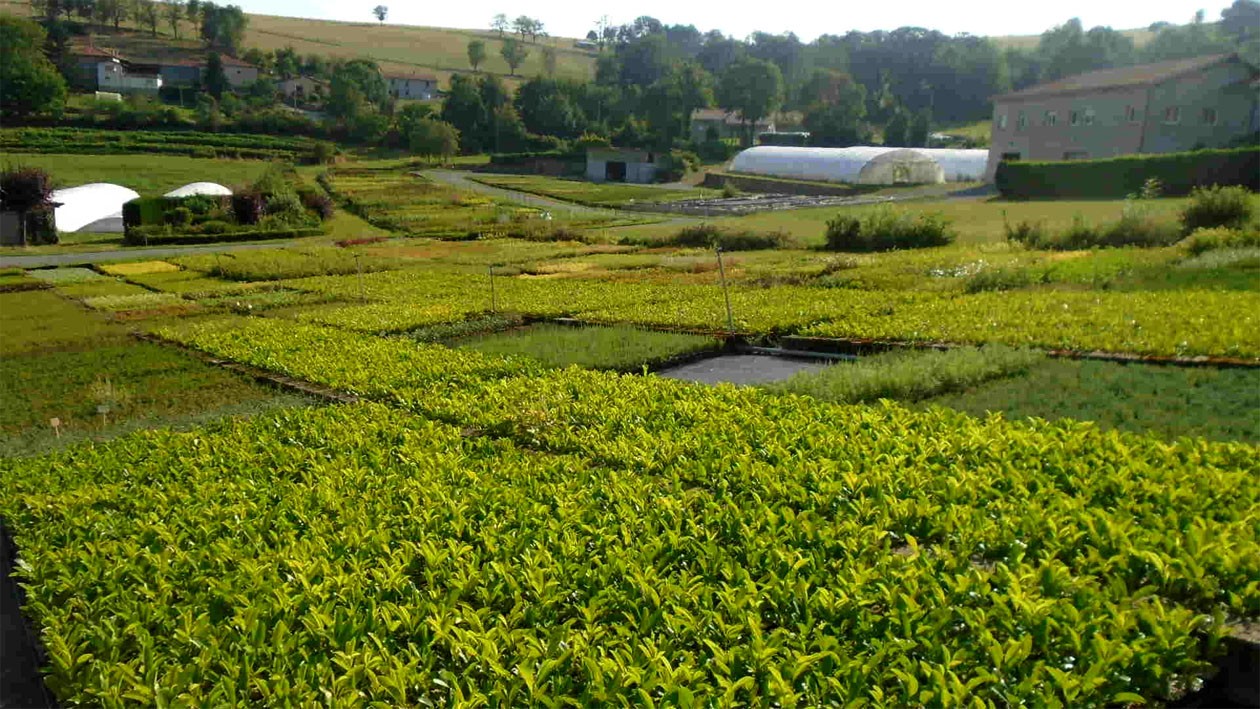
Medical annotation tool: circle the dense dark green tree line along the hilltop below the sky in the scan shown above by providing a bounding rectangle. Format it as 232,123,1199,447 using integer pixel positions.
449,0,1260,149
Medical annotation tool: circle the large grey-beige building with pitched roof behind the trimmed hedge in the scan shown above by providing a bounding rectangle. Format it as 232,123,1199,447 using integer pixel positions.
987,54,1260,180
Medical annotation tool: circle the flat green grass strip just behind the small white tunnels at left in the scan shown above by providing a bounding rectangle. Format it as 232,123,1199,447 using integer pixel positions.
0,152,270,196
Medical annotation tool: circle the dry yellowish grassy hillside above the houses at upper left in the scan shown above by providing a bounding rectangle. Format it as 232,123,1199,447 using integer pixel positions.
0,0,595,87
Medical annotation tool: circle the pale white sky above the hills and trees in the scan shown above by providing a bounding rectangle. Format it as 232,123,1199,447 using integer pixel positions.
227,0,1231,42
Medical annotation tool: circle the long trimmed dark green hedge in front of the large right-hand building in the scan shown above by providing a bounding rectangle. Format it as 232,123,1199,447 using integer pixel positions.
994,147,1260,199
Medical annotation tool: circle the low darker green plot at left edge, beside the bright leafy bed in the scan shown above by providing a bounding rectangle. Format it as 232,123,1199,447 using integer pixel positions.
0,287,311,458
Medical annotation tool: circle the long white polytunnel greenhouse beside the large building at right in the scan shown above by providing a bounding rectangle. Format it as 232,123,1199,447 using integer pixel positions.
731,145,989,185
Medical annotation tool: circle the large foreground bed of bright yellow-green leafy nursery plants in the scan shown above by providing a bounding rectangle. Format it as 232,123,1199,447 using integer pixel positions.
7,317,1260,705
